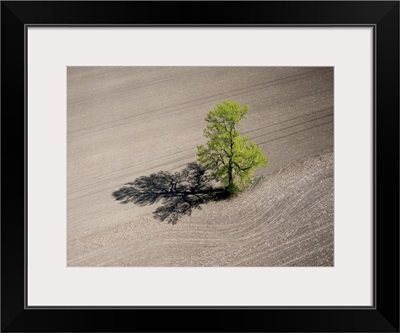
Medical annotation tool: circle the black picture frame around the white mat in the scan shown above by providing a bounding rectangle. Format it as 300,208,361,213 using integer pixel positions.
1,1,399,332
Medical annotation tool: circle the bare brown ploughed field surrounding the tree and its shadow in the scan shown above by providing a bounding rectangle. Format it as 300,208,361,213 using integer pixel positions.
67,67,334,267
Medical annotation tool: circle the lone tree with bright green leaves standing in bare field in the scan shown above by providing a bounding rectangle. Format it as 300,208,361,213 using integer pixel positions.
197,101,269,194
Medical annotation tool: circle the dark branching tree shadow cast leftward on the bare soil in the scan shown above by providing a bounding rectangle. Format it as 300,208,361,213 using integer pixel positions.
112,162,229,224
